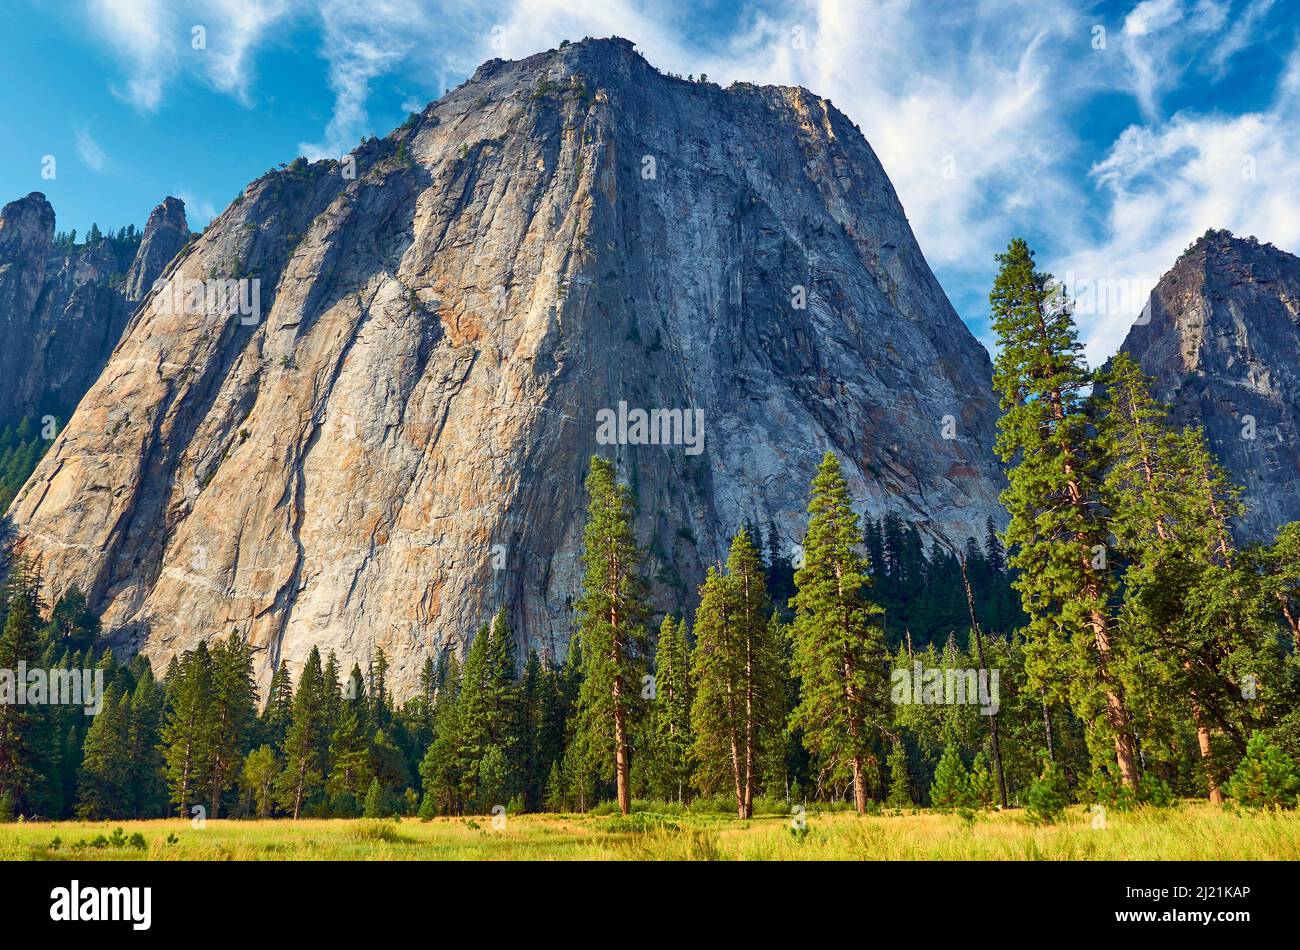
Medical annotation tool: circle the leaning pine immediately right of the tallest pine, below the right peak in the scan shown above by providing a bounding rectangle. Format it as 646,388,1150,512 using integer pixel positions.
1096,353,1282,802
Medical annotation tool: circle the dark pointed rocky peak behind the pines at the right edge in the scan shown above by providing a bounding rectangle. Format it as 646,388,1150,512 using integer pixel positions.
1121,231,1300,541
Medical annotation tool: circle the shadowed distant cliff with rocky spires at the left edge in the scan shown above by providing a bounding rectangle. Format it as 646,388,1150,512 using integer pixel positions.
0,192,189,421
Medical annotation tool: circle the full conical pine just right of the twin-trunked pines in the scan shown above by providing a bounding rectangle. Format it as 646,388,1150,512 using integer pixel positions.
790,452,889,814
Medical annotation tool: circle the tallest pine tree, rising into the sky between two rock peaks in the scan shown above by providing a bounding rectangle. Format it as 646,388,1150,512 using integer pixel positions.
989,238,1138,789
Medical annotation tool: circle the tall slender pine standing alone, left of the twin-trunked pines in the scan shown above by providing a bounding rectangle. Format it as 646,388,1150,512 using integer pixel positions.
577,456,649,815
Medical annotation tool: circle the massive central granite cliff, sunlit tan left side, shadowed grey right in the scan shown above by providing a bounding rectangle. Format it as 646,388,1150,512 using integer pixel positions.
10,39,1001,694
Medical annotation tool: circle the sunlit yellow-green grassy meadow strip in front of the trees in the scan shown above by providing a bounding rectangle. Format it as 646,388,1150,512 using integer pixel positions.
0,803,1300,860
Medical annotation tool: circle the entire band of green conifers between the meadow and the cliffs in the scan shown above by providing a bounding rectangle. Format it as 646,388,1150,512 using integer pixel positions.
0,242,1300,817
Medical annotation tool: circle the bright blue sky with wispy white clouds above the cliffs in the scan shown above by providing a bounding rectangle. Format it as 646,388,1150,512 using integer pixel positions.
0,0,1300,360
